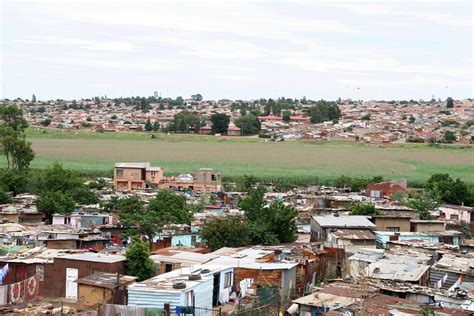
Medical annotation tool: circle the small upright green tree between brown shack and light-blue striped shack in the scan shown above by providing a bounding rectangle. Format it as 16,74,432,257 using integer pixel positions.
125,236,155,281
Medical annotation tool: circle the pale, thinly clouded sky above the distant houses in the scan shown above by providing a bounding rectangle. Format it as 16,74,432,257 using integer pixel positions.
0,0,474,100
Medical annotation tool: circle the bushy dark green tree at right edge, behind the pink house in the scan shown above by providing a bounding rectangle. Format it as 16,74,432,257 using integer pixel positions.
425,173,473,205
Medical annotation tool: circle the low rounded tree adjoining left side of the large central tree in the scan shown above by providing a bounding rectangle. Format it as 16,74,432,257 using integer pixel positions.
200,217,249,250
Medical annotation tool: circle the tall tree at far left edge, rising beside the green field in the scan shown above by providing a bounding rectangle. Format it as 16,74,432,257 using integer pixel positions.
0,105,34,170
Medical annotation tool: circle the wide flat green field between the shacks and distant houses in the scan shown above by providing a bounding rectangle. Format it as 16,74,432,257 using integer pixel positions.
2,129,474,183
